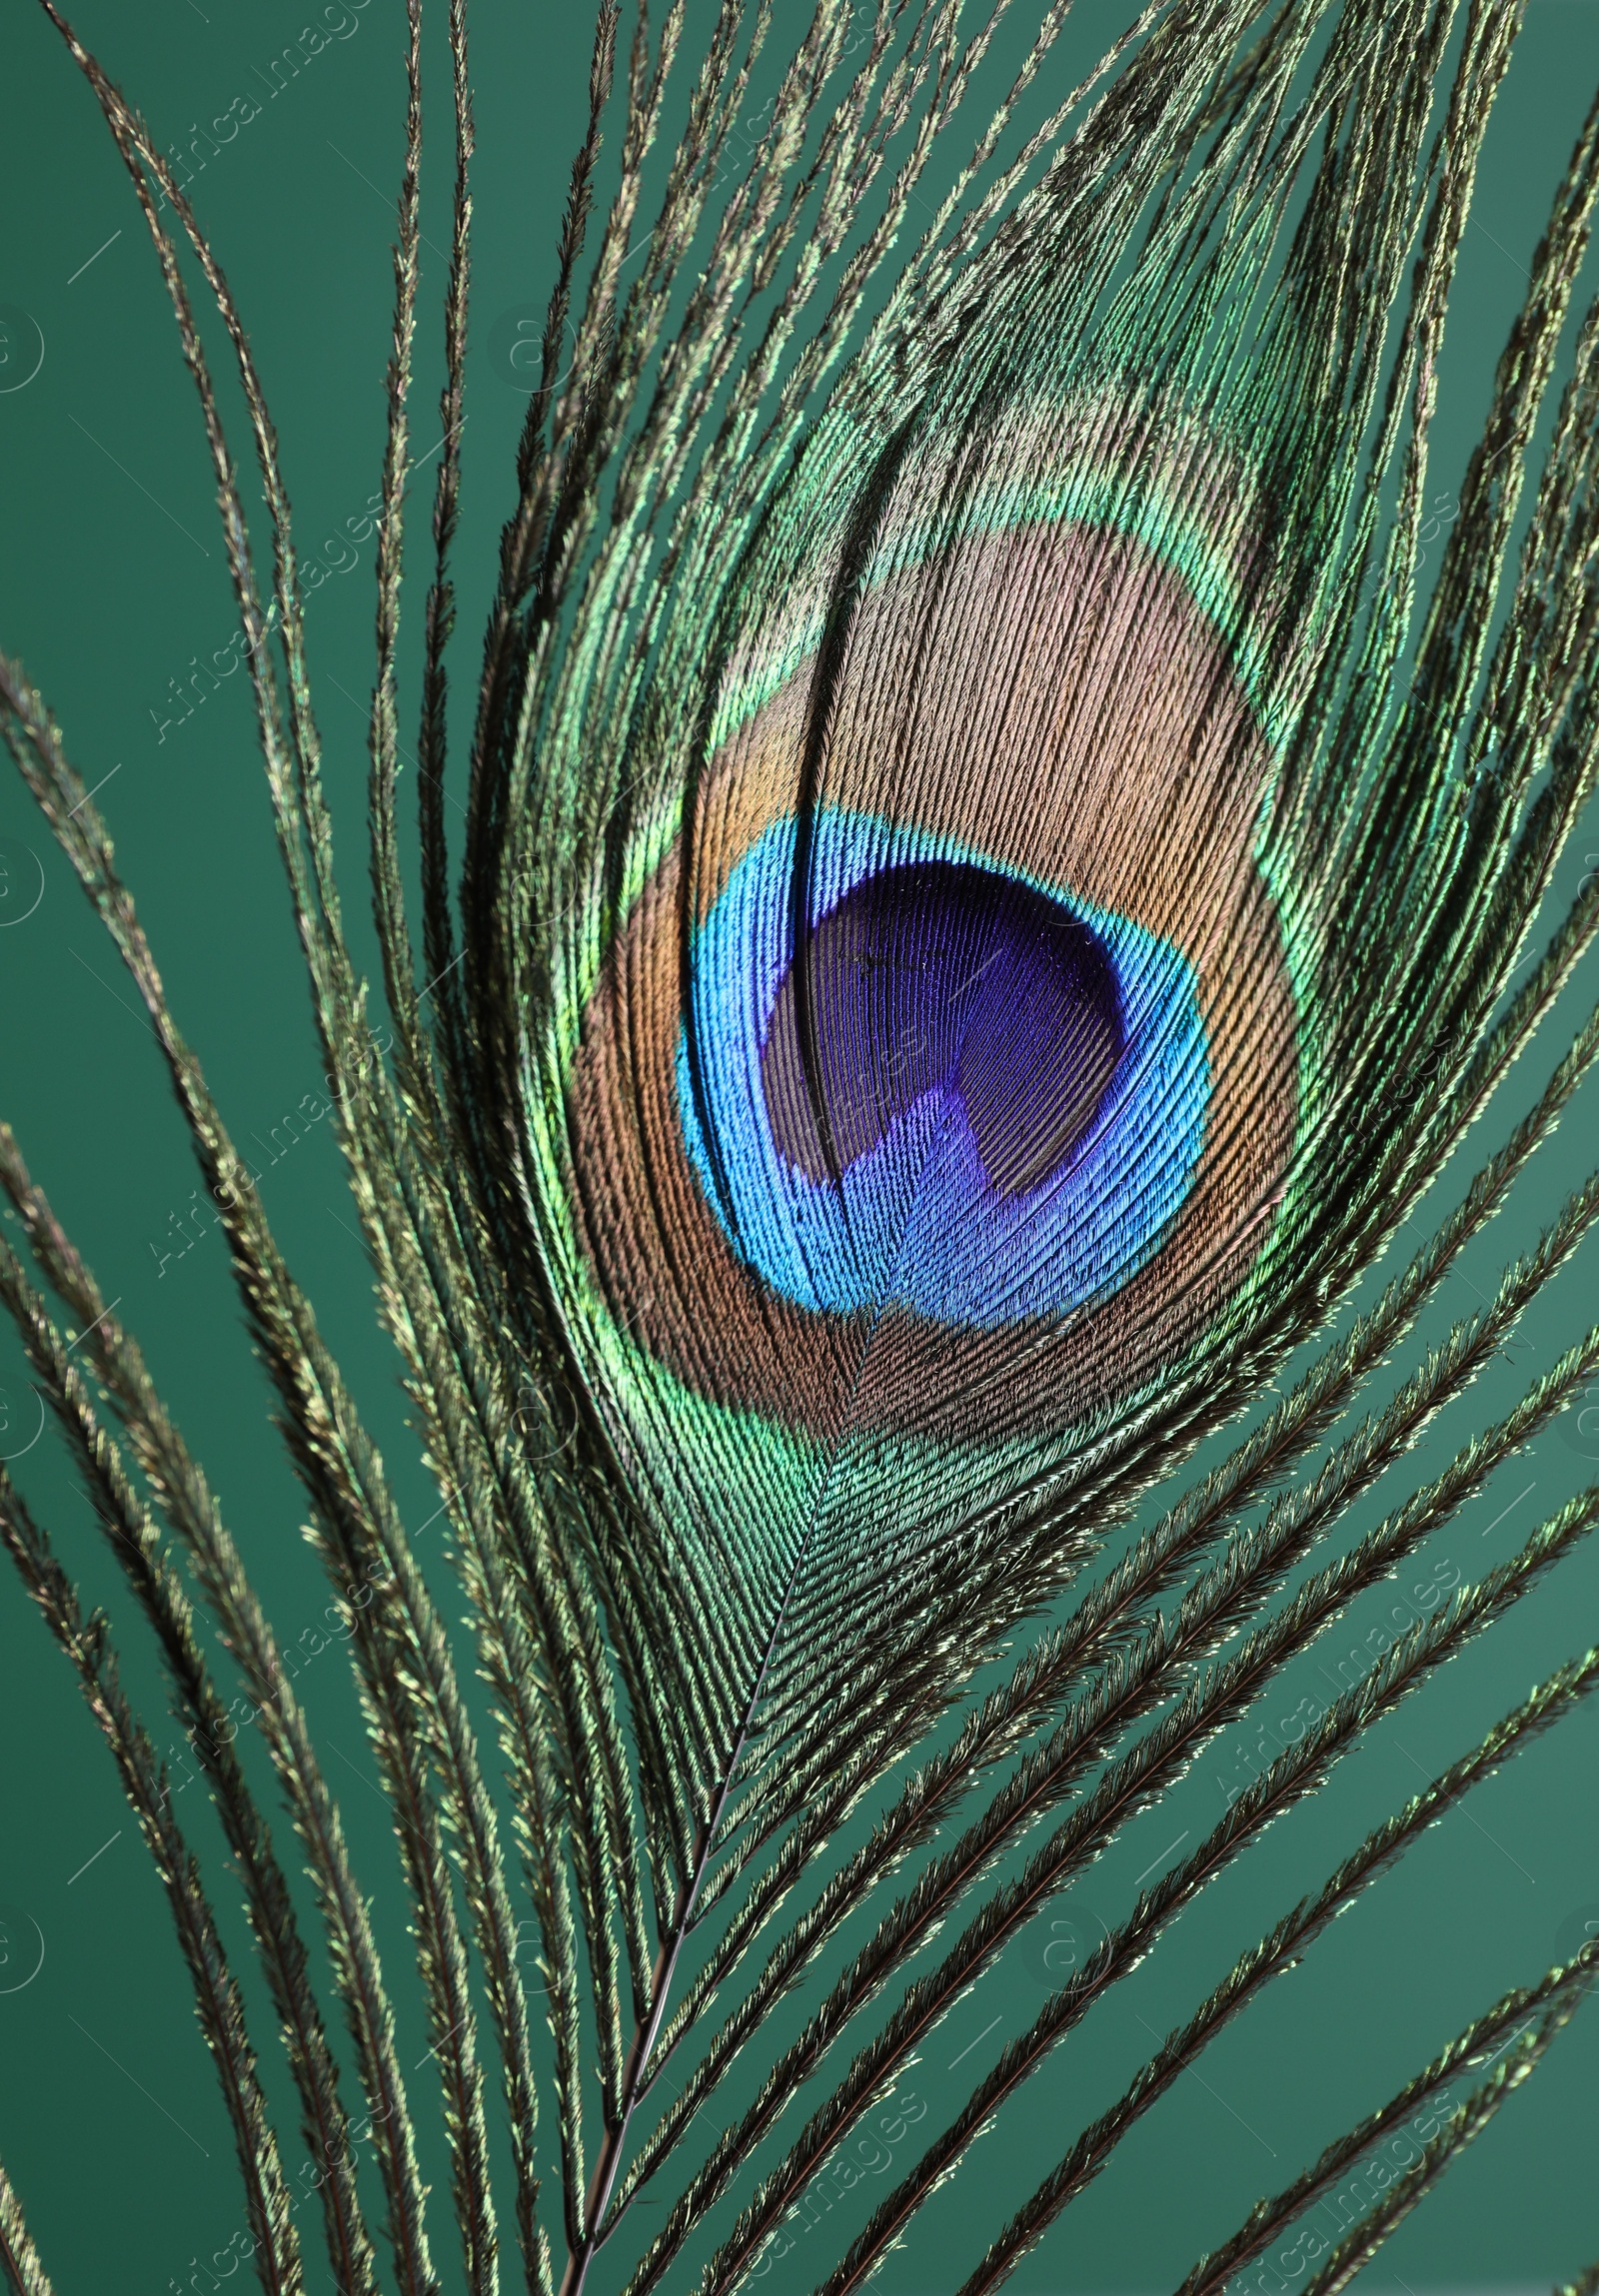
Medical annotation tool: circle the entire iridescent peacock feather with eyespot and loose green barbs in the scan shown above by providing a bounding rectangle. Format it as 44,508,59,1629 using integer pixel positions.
0,0,1599,2296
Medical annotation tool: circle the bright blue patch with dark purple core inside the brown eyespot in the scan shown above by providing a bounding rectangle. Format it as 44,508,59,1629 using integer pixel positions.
678,812,1208,1330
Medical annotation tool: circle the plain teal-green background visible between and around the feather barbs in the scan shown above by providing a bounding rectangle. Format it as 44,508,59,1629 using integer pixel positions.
0,0,1599,2296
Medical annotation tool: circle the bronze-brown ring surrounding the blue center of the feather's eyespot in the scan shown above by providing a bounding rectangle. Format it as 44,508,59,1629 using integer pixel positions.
570,522,1298,1440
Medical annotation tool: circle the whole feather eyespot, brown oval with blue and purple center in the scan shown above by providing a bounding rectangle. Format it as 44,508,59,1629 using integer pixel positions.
572,422,1298,1440
